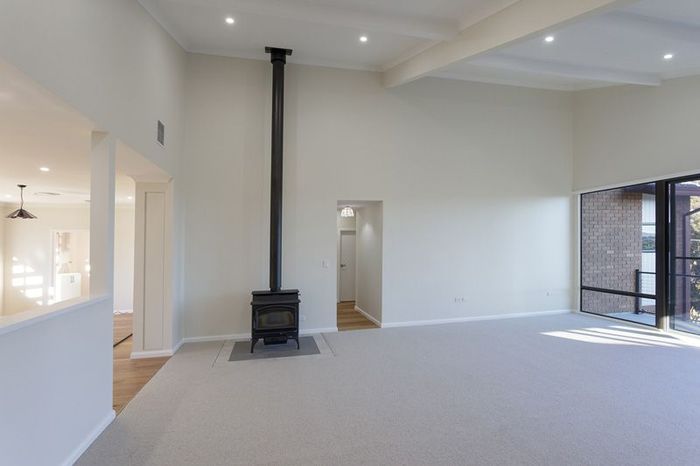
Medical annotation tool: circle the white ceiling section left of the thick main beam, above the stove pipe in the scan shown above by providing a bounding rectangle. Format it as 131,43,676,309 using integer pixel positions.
139,0,515,70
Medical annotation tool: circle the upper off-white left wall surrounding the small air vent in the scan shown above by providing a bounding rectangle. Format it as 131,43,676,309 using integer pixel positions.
0,0,185,175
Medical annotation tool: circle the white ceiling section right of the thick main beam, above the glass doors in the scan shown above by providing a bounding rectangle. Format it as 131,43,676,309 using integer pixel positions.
435,0,700,90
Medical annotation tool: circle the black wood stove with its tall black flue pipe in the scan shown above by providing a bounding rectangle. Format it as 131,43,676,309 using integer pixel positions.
250,47,300,353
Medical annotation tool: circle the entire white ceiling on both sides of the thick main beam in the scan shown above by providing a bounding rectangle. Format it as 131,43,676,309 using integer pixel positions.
139,0,700,90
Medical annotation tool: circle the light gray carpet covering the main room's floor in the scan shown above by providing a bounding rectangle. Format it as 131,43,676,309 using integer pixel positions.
78,315,700,466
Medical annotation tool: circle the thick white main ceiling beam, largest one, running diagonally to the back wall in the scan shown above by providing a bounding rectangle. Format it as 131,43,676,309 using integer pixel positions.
384,0,632,87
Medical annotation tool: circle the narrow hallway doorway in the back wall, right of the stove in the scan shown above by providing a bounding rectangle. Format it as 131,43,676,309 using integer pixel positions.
336,201,383,331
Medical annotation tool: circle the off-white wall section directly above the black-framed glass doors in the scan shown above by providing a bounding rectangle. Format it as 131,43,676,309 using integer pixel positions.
574,73,700,190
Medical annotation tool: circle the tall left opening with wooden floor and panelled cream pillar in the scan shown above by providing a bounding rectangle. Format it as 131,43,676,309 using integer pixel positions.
112,142,173,414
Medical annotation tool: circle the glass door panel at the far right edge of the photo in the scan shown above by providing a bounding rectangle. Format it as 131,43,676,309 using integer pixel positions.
668,178,700,334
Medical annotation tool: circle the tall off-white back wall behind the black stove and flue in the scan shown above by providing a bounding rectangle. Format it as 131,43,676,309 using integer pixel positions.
181,55,573,337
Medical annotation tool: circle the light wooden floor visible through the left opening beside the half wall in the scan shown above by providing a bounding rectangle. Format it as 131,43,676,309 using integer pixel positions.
112,336,170,414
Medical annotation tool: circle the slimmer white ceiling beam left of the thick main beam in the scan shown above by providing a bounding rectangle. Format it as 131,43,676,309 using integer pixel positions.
156,0,459,41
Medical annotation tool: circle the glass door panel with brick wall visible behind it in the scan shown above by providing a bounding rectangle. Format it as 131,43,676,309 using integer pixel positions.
581,183,657,325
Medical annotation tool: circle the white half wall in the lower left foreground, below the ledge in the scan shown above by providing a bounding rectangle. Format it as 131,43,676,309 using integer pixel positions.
0,299,114,466
